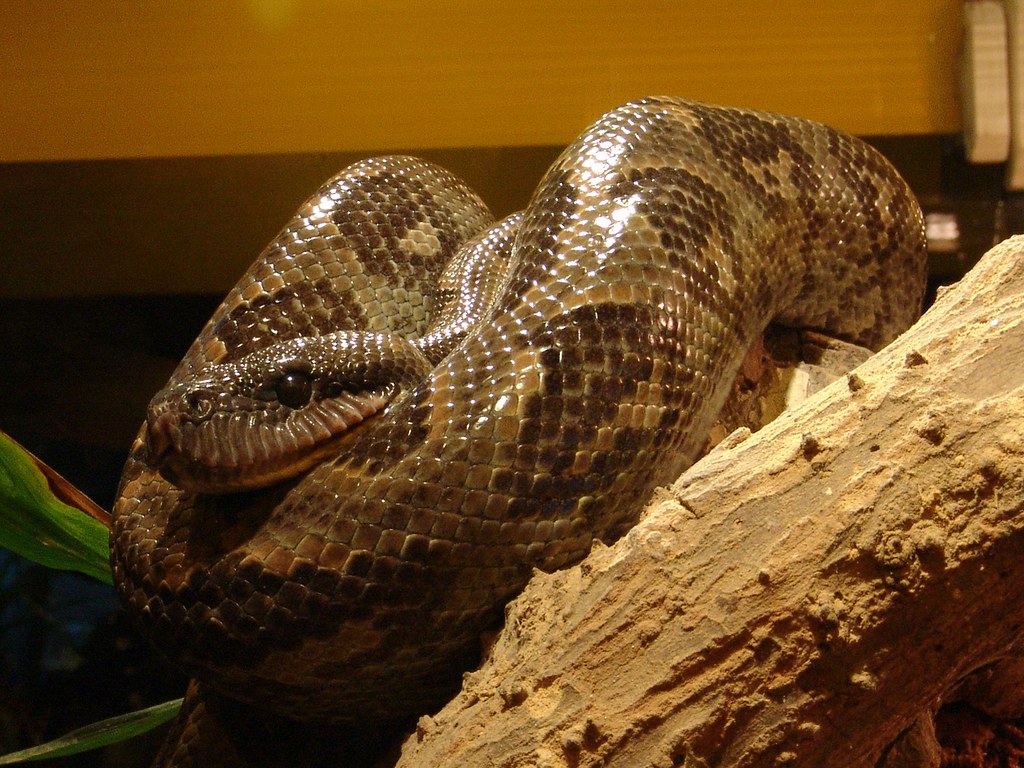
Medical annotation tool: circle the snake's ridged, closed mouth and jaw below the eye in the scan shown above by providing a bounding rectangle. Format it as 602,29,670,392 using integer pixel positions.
146,392,390,494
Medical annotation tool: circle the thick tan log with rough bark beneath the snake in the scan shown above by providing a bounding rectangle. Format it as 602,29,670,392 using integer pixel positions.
398,238,1024,768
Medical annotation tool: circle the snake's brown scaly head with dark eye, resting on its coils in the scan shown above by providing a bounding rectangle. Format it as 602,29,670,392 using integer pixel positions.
146,332,429,494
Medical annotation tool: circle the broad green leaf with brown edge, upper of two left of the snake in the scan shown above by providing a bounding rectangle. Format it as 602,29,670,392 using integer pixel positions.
0,432,113,584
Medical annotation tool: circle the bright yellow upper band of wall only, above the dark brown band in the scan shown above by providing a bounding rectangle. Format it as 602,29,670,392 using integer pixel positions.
0,0,961,162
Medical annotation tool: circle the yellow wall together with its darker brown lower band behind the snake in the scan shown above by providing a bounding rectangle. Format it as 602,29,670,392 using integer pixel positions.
0,0,961,298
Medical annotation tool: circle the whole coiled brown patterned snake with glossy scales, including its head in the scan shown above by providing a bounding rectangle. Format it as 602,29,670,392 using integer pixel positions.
111,97,926,765
